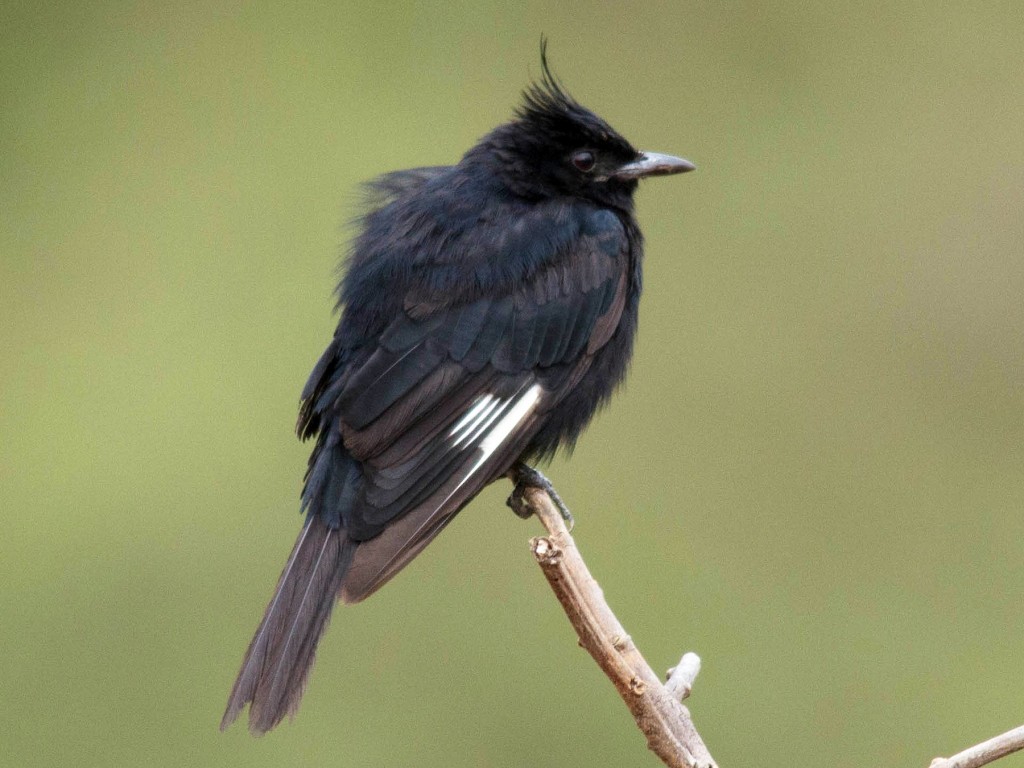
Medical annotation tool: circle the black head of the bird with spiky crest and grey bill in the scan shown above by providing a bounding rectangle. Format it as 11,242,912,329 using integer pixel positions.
467,40,694,206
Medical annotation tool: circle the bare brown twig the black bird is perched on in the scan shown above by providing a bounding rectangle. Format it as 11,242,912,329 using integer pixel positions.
518,487,717,768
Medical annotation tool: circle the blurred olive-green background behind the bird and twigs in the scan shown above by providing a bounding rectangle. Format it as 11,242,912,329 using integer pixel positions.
0,1,1024,768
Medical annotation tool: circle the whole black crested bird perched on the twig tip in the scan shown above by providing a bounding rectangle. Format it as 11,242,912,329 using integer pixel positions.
221,44,693,733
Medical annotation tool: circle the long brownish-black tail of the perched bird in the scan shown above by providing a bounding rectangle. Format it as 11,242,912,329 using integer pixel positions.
220,515,356,734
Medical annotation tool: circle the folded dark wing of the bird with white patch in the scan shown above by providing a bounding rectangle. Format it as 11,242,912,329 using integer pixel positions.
300,207,629,602
